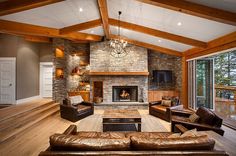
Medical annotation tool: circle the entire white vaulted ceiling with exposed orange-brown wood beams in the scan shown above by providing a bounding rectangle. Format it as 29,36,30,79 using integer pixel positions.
0,0,236,56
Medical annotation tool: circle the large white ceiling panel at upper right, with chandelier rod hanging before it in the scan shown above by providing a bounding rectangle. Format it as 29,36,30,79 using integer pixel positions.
108,0,236,42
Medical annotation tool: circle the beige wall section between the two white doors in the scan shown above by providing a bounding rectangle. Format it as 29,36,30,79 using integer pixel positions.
0,34,40,100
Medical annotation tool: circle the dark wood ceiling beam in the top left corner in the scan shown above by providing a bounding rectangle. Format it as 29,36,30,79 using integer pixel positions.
0,0,64,16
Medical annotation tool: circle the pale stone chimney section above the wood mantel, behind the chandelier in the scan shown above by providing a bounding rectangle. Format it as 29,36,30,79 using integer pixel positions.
90,42,148,72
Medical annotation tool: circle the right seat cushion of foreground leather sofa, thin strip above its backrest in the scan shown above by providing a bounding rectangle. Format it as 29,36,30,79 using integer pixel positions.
126,132,172,138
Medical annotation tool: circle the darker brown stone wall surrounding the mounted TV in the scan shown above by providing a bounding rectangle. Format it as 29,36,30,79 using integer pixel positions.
148,50,182,91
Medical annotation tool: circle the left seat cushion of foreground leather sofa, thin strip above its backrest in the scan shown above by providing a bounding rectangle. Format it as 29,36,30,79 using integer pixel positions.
76,131,125,139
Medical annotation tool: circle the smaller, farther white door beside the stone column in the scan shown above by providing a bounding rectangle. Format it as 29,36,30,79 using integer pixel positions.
40,62,53,98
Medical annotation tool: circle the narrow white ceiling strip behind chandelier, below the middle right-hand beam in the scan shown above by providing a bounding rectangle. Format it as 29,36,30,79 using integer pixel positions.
110,26,192,52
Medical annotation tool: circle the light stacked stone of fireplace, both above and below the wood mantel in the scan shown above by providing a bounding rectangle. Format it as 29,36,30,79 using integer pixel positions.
90,42,148,104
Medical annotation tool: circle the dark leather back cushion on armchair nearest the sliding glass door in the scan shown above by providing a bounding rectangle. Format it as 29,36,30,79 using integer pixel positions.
196,107,215,125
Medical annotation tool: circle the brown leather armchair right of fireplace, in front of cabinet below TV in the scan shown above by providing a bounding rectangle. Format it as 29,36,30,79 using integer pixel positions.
149,96,183,122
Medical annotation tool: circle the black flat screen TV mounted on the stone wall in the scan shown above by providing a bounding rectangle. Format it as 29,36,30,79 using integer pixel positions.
153,70,172,84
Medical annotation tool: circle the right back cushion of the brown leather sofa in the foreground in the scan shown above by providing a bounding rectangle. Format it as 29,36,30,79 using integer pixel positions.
131,135,215,151
